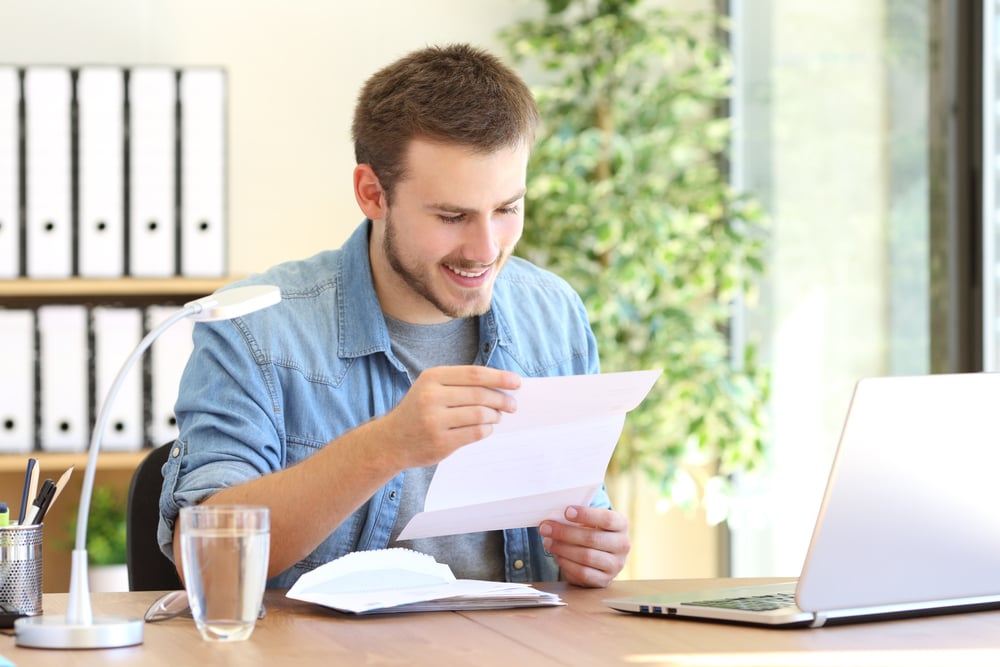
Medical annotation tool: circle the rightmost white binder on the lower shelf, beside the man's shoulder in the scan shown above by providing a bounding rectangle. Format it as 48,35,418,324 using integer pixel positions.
146,306,194,445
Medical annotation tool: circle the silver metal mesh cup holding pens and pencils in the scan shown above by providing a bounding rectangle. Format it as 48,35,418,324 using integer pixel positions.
0,524,43,616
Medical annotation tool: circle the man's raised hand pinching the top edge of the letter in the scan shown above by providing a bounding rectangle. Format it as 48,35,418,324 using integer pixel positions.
384,366,521,468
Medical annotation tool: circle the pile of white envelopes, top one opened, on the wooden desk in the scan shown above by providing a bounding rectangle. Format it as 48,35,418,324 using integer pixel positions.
287,548,565,614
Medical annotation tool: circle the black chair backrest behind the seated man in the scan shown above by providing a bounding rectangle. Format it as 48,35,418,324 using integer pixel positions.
125,442,183,591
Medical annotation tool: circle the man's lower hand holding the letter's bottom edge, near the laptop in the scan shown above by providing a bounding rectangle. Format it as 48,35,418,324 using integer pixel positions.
539,505,632,588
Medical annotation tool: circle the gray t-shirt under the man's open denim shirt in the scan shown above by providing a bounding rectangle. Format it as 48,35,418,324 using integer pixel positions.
385,315,506,581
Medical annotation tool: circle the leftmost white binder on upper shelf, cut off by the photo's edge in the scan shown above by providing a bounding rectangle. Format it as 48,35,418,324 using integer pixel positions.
0,67,21,278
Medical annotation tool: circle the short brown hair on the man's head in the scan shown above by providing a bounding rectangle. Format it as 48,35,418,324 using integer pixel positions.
351,44,538,199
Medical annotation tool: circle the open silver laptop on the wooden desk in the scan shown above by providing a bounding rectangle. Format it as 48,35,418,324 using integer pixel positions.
603,373,1000,627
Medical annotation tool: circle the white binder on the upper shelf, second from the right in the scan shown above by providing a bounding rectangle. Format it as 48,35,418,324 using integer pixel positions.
128,67,177,278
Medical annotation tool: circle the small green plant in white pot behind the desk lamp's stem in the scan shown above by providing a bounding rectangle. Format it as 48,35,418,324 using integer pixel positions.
67,485,128,591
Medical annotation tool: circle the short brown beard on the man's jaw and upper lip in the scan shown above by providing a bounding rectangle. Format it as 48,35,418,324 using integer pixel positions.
382,212,509,319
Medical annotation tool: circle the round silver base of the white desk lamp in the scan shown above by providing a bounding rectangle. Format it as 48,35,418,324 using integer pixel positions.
14,614,143,648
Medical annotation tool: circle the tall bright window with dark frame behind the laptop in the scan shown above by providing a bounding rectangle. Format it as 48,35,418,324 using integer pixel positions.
729,0,976,576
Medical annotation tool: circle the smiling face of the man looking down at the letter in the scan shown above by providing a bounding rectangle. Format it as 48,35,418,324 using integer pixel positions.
370,140,528,324
